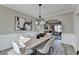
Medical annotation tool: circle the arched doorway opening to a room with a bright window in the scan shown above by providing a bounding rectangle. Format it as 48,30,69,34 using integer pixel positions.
44,19,62,39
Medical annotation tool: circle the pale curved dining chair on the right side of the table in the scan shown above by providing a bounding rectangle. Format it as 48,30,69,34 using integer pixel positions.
36,38,54,54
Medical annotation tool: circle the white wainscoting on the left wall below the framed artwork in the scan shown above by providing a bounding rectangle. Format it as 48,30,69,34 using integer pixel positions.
0,31,37,51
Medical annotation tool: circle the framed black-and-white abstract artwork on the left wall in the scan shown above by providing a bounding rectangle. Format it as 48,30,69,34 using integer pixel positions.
14,16,32,31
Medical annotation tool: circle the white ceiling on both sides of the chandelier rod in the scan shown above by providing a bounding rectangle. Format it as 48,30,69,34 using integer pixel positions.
3,4,73,18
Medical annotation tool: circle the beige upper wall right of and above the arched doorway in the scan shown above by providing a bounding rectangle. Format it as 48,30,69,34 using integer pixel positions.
45,12,73,33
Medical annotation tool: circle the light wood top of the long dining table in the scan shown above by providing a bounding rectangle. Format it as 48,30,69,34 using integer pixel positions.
24,35,52,49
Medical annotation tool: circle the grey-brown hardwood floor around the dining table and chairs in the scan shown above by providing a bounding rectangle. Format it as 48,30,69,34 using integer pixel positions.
0,44,76,55
